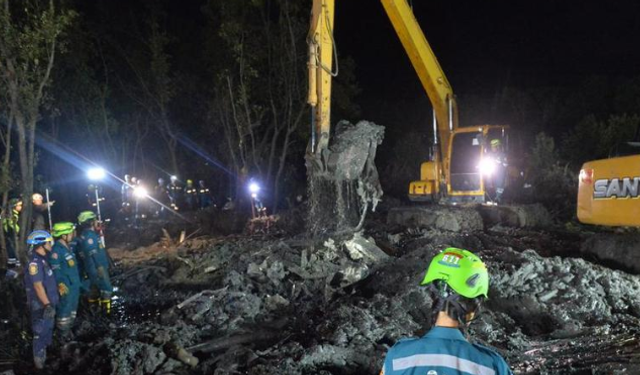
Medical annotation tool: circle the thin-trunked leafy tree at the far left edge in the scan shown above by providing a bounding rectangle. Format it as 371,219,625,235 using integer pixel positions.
0,0,75,262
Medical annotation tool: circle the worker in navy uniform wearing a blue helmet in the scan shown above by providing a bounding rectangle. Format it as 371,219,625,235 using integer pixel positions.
24,230,58,370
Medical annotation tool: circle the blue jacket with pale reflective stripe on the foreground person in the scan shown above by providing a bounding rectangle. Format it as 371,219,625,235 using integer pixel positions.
382,327,512,375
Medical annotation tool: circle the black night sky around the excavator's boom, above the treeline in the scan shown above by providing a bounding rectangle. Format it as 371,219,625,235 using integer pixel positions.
335,0,640,125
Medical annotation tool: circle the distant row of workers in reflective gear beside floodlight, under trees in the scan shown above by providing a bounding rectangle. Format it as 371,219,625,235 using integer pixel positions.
121,174,214,216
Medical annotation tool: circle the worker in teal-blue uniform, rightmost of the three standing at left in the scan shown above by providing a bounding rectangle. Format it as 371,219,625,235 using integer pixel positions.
78,211,113,313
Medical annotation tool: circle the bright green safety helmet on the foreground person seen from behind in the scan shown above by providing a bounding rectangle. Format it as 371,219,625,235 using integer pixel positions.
420,247,489,299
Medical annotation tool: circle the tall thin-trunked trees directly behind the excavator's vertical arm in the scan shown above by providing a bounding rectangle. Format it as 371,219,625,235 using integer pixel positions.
208,0,357,212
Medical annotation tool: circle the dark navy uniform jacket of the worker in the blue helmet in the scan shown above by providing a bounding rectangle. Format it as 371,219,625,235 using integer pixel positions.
24,251,58,311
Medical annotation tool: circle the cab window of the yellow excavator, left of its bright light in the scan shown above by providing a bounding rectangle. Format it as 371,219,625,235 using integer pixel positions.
451,132,483,191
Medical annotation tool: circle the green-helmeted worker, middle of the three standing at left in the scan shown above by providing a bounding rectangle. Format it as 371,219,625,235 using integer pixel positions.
49,222,80,340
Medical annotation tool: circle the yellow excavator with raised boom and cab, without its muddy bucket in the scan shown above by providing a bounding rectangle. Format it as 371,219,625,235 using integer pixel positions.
308,0,506,202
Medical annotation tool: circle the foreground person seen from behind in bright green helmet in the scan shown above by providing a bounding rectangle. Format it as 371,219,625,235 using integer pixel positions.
380,248,512,375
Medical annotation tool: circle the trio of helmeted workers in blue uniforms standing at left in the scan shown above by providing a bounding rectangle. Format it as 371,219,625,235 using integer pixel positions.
24,211,113,369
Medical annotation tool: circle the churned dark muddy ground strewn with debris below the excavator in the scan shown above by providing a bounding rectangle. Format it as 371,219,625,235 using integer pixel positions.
0,209,640,375
